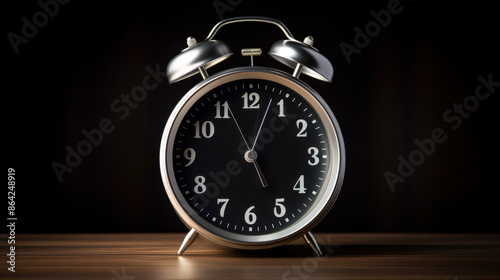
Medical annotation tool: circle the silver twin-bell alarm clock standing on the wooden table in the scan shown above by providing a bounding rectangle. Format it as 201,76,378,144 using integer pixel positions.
160,17,345,255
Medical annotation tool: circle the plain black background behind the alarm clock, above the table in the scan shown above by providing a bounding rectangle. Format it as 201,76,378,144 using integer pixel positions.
2,0,500,233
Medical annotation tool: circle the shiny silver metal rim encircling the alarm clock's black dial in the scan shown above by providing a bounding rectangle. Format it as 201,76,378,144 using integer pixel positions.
160,66,345,249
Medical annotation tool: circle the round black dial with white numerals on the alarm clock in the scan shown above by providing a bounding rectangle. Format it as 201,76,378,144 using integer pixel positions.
164,71,340,236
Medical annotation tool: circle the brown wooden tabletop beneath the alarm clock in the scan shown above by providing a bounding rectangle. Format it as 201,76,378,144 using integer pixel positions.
0,233,500,280
